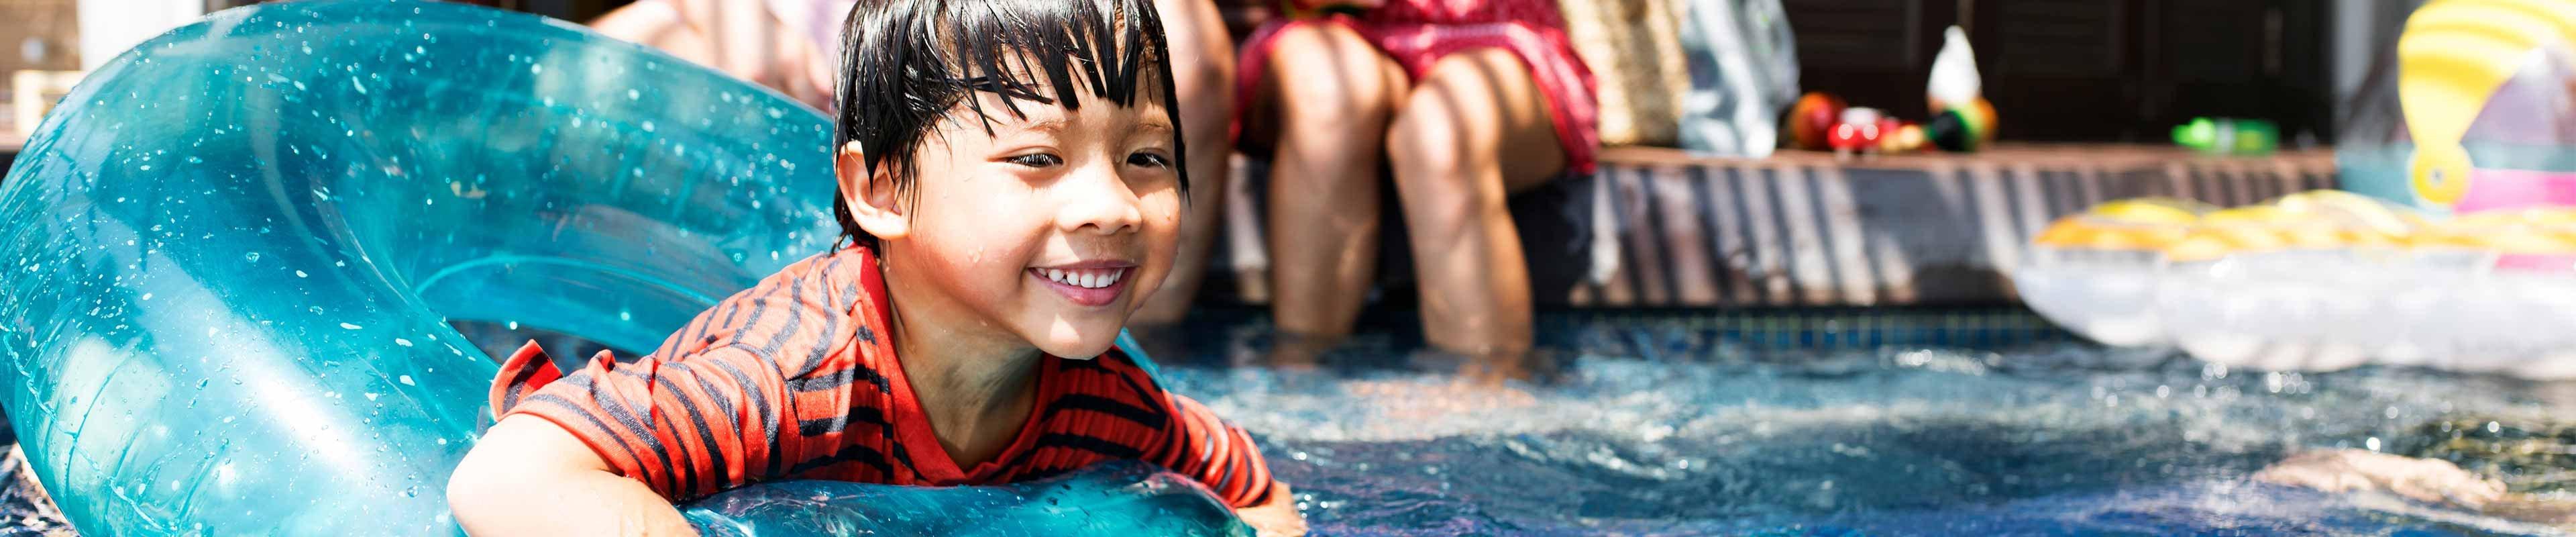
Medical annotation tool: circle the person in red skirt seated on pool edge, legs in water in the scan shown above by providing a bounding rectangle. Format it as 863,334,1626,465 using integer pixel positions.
1236,0,1600,359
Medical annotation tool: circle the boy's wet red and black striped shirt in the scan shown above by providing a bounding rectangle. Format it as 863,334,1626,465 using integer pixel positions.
492,248,1273,506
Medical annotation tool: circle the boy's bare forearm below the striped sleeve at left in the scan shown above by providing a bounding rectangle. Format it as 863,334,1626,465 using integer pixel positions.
448,416,698,537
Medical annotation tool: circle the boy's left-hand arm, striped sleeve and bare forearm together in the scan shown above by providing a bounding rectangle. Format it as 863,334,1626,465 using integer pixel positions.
448,330,837,534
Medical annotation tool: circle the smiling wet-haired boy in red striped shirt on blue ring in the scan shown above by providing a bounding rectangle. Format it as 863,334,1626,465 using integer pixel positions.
448,0,1303,534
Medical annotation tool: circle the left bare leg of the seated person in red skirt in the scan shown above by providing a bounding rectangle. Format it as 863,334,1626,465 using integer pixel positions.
1247,23,1407,344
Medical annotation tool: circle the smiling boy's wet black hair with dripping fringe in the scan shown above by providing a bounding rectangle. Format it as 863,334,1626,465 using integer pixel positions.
832,0,1190,248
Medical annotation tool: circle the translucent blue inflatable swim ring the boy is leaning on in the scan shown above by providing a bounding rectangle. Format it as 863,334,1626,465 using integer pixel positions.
0,0,1232,534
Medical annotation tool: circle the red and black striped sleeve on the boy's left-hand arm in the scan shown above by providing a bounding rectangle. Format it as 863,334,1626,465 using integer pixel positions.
505,346,788,501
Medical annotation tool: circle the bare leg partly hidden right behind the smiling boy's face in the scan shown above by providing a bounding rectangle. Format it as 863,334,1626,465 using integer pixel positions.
1131,0,1234,326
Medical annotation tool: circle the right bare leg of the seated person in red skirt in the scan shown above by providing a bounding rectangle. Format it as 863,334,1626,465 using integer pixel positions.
1386,49,1566,359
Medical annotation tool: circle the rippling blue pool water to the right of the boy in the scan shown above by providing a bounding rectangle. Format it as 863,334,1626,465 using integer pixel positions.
0,310,2576,534
